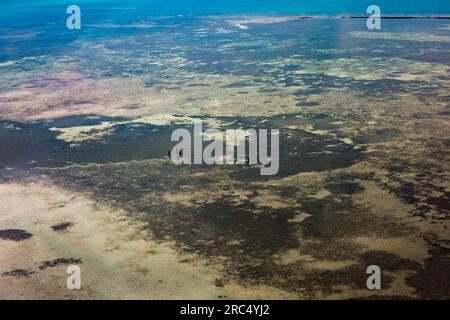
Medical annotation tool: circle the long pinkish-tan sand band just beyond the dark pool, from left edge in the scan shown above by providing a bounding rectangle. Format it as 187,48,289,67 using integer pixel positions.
0,64,298,122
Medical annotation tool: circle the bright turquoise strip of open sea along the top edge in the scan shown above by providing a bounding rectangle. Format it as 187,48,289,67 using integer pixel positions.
0,0,450,28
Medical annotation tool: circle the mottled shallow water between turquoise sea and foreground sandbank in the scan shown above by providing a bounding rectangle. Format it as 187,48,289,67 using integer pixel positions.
0,4,450,298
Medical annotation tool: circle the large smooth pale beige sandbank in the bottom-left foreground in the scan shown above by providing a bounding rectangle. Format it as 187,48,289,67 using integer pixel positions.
0,182,236,299
